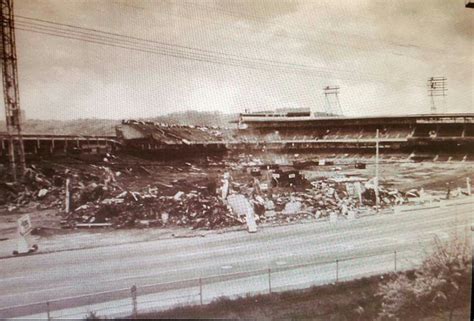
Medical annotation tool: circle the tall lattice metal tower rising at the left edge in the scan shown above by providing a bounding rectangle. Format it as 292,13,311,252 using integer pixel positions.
1,0,25,181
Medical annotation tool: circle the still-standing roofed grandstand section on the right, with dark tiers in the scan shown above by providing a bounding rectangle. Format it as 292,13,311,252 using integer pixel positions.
238,113,474,160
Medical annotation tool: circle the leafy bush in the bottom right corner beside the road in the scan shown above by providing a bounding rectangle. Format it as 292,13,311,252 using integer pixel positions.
378,232,471,320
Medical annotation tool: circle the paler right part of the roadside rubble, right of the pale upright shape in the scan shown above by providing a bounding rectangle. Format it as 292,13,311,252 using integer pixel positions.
220,160,412,223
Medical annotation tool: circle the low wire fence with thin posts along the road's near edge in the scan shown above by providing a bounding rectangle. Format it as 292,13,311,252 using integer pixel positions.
23,250,420,320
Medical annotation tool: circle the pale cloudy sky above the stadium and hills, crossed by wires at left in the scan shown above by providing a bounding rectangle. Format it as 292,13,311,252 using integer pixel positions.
2,0,474,119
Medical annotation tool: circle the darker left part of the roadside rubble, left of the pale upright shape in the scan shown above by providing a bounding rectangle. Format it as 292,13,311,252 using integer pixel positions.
0,155,242,229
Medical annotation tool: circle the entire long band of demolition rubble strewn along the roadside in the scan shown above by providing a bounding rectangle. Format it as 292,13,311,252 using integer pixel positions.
0,155,468,231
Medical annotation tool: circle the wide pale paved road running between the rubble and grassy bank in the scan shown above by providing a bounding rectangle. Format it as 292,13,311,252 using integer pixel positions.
0,199,473,318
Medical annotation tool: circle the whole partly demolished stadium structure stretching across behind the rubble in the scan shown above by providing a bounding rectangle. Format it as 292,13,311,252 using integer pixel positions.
0,113,474,160
